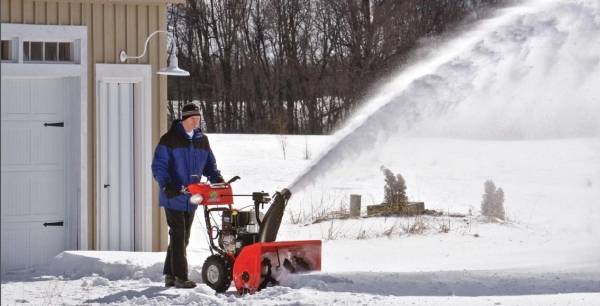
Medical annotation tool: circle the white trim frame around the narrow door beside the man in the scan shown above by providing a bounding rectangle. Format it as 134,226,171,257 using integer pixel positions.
95,64,152,252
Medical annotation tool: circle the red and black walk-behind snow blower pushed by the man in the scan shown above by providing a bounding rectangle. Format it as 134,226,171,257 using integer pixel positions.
187,176,321,294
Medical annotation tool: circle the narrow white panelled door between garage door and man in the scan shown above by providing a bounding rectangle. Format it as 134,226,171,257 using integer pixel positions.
97,82,135,251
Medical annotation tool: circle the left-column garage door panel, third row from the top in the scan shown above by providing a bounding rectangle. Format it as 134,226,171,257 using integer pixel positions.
2,172,32,220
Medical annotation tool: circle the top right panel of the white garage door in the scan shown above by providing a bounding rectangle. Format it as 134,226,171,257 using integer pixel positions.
31,79,65,114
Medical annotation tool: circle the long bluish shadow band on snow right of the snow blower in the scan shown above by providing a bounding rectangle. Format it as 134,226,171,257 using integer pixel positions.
282,270,600,296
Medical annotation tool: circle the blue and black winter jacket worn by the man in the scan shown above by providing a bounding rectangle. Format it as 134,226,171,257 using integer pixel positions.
152,120,222,211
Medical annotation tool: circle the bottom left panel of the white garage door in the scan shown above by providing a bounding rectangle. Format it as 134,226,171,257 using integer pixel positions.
2,224,30,272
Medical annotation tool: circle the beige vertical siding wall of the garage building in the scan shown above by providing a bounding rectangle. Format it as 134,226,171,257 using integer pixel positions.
0,0,167,251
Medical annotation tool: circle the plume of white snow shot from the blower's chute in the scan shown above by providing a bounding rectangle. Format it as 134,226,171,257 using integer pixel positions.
288,0,600,192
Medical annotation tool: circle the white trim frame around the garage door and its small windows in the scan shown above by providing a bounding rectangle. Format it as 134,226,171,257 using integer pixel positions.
0,23,89,250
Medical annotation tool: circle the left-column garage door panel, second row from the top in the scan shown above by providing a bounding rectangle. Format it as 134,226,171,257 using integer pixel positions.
2,126,31,166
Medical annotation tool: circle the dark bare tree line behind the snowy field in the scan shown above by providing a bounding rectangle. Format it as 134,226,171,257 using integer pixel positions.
168,0,502,134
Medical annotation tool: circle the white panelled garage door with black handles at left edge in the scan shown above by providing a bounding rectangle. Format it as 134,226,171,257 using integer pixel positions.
1,78,70,271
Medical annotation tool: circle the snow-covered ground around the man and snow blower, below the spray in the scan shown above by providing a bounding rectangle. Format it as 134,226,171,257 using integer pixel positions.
2,135,600,305
